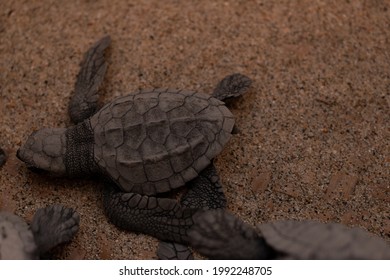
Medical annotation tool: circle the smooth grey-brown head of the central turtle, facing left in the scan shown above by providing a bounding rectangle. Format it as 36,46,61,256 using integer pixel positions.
16,128,66,175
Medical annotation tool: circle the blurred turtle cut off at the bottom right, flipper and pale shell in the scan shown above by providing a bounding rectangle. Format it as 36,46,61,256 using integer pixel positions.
188,210,390,259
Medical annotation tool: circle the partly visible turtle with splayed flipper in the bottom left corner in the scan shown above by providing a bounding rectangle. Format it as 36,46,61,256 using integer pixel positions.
0,205,80,260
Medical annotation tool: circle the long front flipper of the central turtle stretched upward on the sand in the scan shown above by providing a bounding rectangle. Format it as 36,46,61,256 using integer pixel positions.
69,36,111,124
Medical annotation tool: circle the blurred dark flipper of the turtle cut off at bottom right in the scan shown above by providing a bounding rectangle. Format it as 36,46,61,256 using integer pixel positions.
188,210,272,259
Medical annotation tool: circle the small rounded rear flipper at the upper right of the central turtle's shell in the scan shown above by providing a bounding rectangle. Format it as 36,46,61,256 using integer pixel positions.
212,73,252,100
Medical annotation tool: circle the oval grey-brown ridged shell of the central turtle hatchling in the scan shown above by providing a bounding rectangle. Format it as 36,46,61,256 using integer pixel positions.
90,89,234,195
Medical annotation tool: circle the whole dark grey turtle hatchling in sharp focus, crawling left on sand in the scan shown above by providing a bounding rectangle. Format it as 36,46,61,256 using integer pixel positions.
17,36,251,241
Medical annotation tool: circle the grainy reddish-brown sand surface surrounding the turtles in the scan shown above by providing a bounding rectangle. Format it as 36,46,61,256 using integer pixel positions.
0,0,390,259
